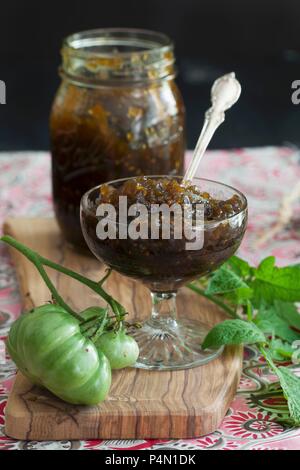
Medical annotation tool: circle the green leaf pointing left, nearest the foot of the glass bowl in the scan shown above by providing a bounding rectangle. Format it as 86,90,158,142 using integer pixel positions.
202,319,265,349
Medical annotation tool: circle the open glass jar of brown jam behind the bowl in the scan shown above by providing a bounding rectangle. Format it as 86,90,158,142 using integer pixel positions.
50,29,185,246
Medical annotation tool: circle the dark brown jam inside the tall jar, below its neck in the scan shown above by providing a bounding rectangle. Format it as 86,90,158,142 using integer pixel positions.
50,81,185,250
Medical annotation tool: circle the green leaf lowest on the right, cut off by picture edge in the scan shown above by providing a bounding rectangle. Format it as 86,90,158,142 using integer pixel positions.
276,367,300,426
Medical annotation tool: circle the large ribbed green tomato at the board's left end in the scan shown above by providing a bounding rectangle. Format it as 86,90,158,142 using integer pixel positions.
7,304,111,405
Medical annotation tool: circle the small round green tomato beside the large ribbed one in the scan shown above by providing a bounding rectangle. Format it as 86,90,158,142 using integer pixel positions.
95,330,139,369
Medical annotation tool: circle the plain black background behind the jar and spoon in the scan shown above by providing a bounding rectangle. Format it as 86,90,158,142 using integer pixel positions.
0,0,300,150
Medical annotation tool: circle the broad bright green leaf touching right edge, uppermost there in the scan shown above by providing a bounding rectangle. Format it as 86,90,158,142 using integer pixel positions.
250,256,300,306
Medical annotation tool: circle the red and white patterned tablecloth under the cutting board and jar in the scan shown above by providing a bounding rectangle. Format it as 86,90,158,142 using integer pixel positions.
0,147,300,450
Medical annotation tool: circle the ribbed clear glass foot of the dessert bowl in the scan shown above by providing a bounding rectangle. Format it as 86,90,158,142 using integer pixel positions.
131,317,223,370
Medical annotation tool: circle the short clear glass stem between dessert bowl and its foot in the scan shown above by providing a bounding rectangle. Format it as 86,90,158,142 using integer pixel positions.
151,292,177,322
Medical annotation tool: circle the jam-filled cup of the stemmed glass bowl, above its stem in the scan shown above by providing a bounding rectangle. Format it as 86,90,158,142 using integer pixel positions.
81,177,247,291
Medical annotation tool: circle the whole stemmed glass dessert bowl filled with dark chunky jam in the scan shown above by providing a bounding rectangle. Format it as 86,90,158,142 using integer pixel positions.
81,176,247,370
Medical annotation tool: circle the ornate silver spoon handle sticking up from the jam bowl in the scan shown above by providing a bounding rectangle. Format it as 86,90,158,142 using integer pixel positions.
183,72,241,182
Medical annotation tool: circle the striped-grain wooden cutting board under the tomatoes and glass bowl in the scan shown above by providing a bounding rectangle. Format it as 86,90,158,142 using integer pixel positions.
4,218,242,440
